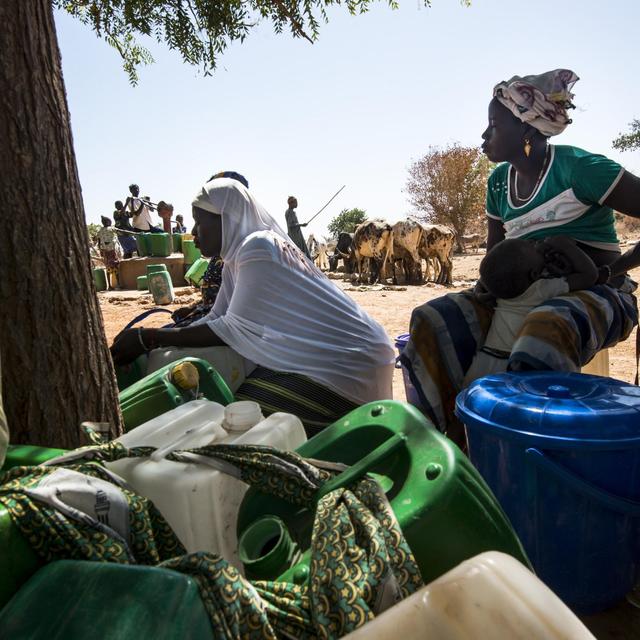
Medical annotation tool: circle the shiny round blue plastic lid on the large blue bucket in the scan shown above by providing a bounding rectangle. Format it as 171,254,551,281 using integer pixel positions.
456,371,640,449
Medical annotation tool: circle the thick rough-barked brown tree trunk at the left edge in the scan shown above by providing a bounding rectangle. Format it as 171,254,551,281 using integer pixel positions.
0,0,121,448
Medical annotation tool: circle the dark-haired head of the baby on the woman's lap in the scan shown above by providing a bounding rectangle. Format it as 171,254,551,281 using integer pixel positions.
480,239,545,299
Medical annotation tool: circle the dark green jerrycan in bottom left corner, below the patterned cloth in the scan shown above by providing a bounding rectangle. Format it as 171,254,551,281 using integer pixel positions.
0,560,215,640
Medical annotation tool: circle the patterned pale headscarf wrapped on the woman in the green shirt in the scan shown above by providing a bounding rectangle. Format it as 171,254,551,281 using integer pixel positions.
493,69,579,136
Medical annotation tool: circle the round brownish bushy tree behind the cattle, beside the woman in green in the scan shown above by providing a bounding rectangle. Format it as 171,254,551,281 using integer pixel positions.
405,144,493,251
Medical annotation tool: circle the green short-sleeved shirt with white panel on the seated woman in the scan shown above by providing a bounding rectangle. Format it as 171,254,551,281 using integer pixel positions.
487,145,624,251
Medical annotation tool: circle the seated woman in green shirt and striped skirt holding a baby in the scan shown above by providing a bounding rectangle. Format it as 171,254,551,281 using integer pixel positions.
402,69,640,443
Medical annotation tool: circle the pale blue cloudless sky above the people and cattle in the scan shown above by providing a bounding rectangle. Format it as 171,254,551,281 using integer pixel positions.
56,0,640,234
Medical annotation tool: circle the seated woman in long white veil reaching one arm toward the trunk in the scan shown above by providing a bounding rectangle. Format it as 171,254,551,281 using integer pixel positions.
111,178,394,434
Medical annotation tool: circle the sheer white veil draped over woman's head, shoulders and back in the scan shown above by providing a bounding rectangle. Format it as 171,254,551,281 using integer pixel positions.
193,178,395,403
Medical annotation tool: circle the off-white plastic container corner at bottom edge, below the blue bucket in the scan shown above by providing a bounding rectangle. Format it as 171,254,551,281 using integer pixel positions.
345,551,595,640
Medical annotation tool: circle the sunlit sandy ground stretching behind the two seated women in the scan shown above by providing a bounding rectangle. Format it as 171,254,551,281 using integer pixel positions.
98,252,640,399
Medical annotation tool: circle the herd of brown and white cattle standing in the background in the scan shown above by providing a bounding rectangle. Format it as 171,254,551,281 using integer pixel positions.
307,218,480,284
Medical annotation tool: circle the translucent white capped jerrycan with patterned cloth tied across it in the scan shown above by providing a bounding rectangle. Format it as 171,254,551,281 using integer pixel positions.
107,400,306,568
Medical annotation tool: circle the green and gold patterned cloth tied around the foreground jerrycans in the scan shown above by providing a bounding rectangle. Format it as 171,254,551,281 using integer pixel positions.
0,442,422,640
